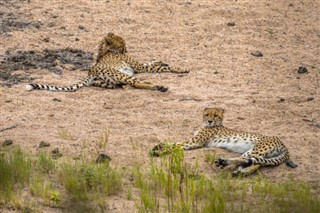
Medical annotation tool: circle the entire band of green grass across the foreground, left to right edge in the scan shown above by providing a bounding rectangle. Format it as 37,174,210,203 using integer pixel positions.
0,145,320,212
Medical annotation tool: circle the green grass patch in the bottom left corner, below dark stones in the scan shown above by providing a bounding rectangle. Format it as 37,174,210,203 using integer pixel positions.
0,144,122,210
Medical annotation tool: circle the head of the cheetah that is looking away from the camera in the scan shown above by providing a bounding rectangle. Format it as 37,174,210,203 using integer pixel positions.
97,33,127,61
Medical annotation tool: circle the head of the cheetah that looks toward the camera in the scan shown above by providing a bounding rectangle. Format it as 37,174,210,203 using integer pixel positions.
203,108,224,127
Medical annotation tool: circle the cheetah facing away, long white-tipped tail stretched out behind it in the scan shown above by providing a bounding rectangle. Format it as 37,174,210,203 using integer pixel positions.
26,33,189,92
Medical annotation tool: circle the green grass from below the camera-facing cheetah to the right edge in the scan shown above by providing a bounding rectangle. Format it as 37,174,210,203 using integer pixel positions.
133,146,320,212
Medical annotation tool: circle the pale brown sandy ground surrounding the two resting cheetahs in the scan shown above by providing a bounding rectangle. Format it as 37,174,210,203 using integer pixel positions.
0,0,320,212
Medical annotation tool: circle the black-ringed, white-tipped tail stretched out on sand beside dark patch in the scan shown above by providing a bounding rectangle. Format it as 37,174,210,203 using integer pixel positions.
26,76,94,92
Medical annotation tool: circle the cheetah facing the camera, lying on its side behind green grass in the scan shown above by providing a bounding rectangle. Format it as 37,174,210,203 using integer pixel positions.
150,108,297,176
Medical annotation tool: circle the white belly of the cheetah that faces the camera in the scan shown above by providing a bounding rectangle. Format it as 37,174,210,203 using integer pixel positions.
207,137,255,154
